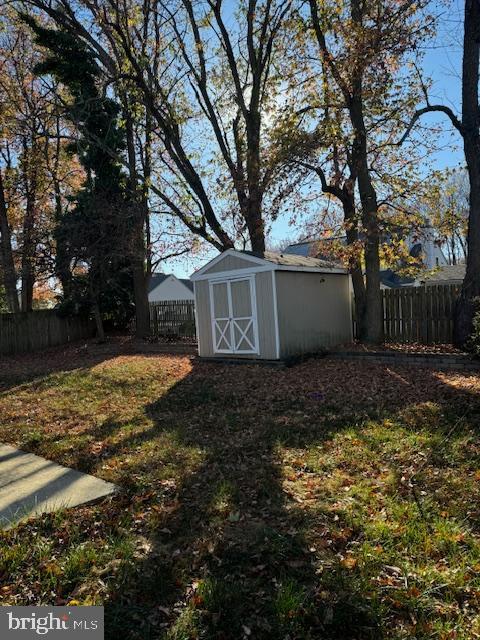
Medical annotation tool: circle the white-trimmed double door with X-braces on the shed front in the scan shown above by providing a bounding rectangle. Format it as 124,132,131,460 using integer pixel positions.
210,277,258,354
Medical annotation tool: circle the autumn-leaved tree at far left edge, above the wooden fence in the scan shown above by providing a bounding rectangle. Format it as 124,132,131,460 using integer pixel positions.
0,10,75,311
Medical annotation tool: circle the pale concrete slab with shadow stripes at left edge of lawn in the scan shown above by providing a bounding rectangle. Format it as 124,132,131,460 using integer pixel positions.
0,444,116,528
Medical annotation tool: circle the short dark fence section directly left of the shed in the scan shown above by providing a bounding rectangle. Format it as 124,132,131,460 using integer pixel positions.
150,300,196,338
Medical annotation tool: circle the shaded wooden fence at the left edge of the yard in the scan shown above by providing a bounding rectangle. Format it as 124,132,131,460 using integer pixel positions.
0,309,95,355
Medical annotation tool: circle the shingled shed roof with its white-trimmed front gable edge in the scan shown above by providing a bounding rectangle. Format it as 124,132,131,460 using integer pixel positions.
191,249,348,280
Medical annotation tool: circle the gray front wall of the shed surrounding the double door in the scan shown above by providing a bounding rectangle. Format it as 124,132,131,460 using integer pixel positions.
195,270,277,360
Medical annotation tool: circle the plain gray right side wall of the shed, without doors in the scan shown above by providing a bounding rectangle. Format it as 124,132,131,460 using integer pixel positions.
275,271,352,358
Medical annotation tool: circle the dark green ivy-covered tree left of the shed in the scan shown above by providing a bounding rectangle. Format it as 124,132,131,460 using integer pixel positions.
23,16,136,338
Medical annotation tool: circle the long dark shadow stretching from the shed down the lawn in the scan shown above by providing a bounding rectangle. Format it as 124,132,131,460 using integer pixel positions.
100,364,480,640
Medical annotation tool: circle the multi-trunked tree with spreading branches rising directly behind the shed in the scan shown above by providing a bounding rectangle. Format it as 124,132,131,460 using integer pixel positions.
21,0,292,251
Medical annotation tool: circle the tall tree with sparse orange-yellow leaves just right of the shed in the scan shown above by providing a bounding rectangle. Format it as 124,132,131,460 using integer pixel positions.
278,0,429,342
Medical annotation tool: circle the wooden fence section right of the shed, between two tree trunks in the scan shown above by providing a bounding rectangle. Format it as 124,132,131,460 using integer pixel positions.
382,285,460,344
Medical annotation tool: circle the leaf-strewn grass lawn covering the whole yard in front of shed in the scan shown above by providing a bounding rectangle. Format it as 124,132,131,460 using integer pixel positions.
0,343,480,640
